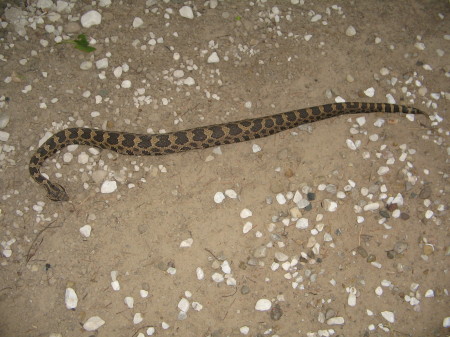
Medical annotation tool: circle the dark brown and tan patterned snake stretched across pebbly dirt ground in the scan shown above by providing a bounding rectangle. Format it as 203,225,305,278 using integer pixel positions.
29,102,427,201
